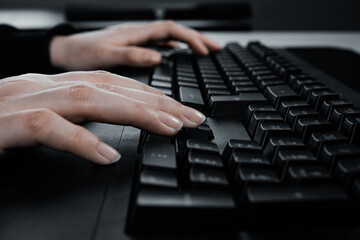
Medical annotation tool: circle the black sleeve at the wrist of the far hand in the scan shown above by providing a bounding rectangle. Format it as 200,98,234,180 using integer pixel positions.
0,24,76,78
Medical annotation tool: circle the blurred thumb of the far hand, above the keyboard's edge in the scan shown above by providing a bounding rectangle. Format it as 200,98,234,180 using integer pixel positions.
114,46,161,67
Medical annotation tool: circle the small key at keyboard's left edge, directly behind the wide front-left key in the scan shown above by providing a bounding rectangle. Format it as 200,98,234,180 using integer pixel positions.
140,169,179,188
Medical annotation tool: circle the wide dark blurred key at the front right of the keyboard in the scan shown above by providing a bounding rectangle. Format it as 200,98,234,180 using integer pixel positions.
244,183,351,226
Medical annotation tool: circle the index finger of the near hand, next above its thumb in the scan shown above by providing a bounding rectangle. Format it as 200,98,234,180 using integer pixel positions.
13,83,183,135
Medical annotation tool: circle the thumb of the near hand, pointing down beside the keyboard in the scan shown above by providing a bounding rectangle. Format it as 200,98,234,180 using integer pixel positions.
0,109,120,164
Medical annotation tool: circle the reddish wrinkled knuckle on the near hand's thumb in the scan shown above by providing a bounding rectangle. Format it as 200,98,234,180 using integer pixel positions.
25,109,53,132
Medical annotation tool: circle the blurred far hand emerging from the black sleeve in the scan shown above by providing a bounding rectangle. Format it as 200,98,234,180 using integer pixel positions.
50,21,221,70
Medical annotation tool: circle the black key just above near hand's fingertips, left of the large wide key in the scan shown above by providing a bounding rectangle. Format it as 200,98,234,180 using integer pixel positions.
179,87,204,112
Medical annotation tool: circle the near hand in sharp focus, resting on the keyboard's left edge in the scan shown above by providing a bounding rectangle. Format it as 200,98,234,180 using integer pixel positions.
0,71,205,164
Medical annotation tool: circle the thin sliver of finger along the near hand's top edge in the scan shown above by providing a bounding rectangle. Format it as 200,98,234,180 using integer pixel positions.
51,71,163,95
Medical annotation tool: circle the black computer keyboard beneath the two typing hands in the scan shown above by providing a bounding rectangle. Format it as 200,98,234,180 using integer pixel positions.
127,42,360,233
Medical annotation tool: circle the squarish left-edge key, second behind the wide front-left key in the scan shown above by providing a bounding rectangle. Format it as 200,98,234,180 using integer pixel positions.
141,142,176,170
